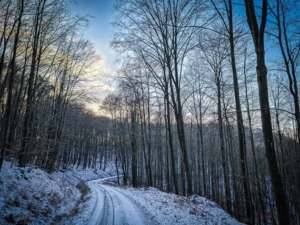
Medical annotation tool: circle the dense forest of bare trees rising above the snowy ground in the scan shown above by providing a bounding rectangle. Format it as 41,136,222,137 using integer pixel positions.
0,0,300,225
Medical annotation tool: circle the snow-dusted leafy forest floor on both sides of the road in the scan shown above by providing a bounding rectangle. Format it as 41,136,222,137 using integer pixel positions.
0,161,241,225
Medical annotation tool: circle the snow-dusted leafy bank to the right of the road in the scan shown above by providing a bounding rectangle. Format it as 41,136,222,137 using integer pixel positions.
113,187,242,225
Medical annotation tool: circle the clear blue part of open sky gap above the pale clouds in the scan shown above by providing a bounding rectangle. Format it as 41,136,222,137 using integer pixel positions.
71,0,115,69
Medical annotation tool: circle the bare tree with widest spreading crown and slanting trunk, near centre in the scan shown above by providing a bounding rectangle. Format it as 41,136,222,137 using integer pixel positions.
112,0,211,195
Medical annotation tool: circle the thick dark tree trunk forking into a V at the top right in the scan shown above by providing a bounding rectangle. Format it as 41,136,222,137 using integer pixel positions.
245,0,290,225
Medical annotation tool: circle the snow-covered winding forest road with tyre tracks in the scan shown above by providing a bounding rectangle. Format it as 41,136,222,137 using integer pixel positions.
87,177,151,225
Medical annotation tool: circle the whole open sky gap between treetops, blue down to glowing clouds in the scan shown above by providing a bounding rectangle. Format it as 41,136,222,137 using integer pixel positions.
70,0,116,113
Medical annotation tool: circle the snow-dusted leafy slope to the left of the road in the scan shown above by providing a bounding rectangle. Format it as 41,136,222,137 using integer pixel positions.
0,161,109,225
